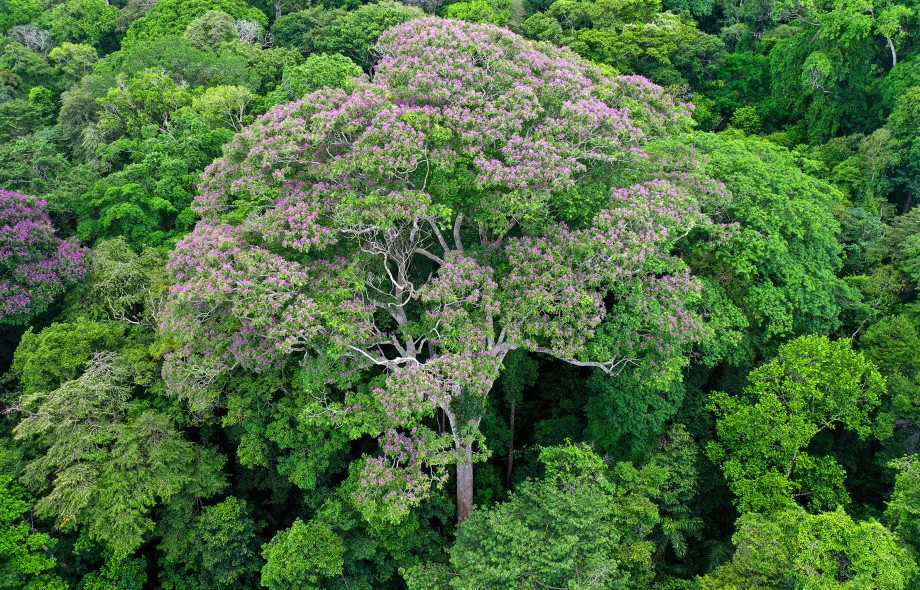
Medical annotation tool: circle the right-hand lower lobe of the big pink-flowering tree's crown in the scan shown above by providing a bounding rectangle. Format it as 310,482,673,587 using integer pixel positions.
503,180,707,359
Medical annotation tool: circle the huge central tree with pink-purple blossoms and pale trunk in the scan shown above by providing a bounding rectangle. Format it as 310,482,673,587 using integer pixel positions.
161,18,705,521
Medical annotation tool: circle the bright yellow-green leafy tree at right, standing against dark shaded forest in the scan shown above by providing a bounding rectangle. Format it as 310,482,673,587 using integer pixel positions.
709,336,885,512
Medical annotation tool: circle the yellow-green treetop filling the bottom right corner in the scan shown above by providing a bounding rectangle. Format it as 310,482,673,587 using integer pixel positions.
700,509,917,590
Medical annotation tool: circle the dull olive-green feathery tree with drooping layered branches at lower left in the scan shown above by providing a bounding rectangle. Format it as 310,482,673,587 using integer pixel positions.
14,353,224,559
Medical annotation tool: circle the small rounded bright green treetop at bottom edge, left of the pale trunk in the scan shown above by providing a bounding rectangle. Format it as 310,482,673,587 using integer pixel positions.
262,518,345,590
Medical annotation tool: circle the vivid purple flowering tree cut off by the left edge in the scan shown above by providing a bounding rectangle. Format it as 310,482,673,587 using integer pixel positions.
0,189,86,325
